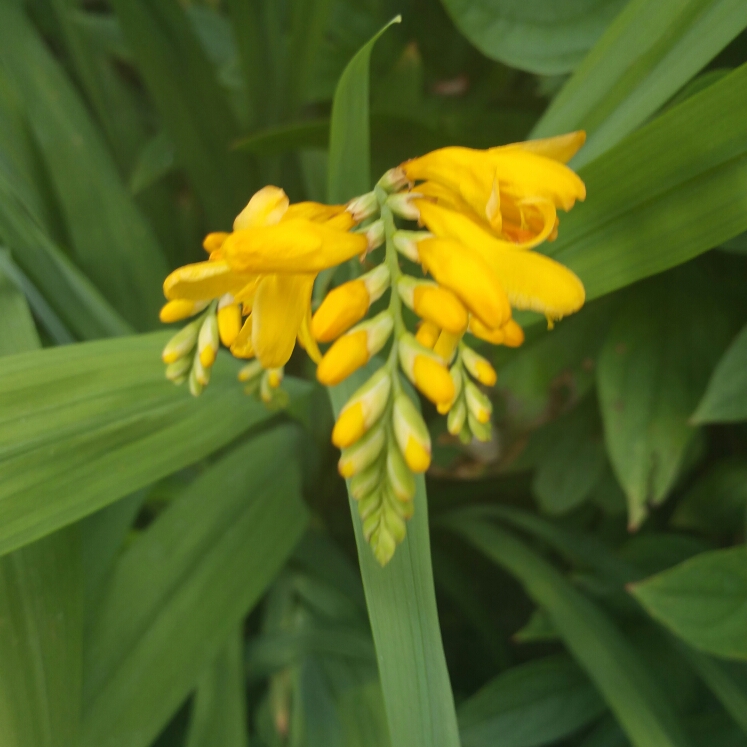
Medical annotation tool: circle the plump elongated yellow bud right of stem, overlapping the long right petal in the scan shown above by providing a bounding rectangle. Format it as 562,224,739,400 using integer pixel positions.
418,239,520,328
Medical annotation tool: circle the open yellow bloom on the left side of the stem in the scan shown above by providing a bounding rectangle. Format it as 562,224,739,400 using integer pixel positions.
161,187,368,369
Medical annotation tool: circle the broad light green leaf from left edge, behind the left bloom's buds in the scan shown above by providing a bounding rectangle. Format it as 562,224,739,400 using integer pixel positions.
0,333,280,553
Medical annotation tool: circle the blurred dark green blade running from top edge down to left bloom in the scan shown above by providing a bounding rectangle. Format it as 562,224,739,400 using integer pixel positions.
112,0,261,230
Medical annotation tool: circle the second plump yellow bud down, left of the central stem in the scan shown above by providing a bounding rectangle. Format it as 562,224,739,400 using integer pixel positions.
316,311,394,386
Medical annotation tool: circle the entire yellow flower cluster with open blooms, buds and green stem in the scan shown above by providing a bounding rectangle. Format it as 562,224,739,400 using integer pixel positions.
161,132,585,564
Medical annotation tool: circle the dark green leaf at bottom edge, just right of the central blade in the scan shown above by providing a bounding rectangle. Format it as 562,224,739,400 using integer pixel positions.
458,654,605,747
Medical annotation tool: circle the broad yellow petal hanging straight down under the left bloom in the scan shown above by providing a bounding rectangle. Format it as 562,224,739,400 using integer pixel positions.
252,275,314,368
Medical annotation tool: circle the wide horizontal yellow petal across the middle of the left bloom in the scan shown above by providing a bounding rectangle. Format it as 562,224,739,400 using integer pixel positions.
221,219,368,273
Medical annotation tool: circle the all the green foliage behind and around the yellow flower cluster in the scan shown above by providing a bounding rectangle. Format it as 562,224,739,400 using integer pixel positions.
0,0,747,747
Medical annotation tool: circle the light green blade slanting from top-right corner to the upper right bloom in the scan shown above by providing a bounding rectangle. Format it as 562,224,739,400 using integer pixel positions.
532,0,747,167
